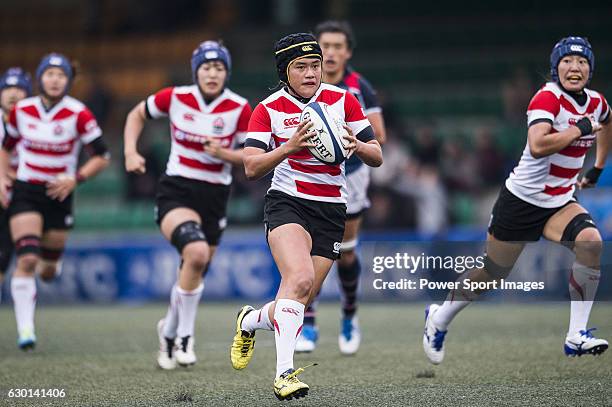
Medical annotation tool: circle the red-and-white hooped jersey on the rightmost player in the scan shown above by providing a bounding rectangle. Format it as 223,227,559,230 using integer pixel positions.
506,82,610,208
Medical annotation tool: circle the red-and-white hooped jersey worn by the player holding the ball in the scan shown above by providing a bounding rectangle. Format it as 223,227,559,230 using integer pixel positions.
247,83,370,203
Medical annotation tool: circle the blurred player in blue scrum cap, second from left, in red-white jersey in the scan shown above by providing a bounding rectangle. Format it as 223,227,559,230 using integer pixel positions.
0,53,109,349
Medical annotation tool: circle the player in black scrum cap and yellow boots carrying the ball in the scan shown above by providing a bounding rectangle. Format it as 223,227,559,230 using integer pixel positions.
230,33,382,400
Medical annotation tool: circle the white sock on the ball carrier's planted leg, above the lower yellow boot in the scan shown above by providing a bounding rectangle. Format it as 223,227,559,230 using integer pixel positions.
274,299,305,377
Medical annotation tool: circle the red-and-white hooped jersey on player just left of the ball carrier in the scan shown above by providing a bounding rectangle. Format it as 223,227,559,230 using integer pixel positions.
147,85,251,185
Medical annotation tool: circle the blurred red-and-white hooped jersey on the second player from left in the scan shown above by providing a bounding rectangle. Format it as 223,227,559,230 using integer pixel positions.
5,96,102,184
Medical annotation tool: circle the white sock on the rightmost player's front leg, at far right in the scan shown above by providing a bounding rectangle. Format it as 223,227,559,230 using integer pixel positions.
567,262,601,336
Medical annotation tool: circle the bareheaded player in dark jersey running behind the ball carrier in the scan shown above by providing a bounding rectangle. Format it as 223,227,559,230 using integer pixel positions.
296,21,385,355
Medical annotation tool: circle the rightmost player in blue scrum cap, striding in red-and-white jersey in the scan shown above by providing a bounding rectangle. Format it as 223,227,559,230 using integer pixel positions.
423,37,612,364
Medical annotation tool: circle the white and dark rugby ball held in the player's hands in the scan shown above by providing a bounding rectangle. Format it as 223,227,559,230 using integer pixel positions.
300,102,348,165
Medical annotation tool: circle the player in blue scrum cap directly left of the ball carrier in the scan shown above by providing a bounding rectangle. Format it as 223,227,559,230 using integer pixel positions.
125,41,251,369
